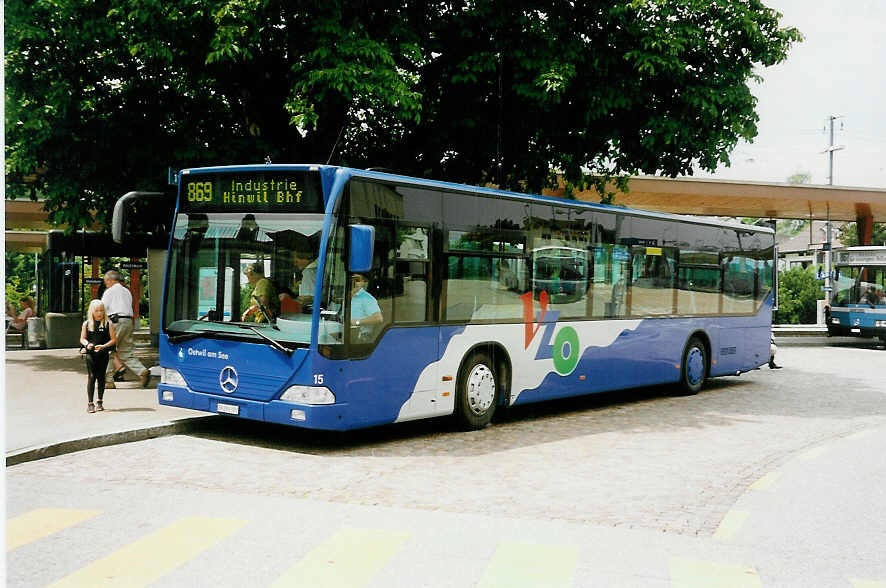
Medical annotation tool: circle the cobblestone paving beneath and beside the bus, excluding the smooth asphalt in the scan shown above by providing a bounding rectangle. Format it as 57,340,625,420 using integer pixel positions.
7,345,886,537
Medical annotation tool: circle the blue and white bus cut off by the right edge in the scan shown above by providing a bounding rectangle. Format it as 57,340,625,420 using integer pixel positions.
826,247,886,343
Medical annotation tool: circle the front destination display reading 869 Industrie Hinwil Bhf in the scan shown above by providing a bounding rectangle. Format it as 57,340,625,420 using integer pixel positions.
179,171,323,212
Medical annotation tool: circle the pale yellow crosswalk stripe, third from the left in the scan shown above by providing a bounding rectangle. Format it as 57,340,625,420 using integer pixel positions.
271,529,409,588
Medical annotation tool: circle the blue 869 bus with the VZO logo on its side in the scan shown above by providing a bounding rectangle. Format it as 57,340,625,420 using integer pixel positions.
146,165,774,430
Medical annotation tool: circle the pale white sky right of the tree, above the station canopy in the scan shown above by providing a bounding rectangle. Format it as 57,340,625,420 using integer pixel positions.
696,0,886,189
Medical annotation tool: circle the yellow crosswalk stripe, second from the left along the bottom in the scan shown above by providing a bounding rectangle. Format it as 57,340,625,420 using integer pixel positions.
52,517,246,587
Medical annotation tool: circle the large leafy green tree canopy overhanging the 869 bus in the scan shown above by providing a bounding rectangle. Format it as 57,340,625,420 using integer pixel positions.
5,0,801,226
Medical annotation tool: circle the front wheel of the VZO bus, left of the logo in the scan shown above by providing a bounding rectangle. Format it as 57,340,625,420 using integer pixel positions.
455,352,500,431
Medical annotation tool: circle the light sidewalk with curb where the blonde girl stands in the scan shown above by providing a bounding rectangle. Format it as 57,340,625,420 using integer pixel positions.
5,348,211,466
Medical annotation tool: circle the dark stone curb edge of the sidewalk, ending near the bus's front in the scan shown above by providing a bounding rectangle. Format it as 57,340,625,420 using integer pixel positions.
6,415,213,467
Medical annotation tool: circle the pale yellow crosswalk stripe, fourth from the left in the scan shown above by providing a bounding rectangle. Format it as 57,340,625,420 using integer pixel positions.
478,541,578,588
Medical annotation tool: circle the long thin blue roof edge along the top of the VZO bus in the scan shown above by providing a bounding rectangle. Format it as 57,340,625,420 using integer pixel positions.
180,164,775,234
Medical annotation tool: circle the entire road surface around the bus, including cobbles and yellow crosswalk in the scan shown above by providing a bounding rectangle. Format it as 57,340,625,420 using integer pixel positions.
7,343,886,586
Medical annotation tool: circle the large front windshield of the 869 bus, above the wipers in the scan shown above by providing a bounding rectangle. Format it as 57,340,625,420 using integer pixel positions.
164,212,323,345
